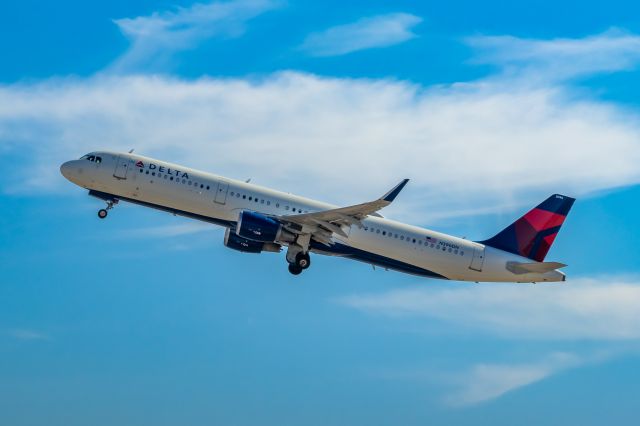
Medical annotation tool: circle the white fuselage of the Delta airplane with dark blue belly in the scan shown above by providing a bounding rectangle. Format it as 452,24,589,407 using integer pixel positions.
61,151,564,282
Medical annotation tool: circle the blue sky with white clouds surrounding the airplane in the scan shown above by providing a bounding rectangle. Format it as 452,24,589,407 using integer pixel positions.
0,0,640,426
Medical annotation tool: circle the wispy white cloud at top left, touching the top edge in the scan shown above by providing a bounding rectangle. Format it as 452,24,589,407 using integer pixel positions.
111,0,281,71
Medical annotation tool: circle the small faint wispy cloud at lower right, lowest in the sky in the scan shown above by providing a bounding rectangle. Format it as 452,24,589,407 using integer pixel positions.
445,352,585,406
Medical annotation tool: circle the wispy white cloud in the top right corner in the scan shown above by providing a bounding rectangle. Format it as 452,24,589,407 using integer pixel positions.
467,29,640,81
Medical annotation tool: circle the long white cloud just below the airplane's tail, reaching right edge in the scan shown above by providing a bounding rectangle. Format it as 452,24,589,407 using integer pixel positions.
339,279,640,341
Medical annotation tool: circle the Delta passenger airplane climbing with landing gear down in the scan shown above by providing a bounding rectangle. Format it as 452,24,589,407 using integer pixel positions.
60,151,575,283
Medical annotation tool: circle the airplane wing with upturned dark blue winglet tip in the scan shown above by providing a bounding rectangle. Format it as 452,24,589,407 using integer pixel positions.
278,179,409,245
